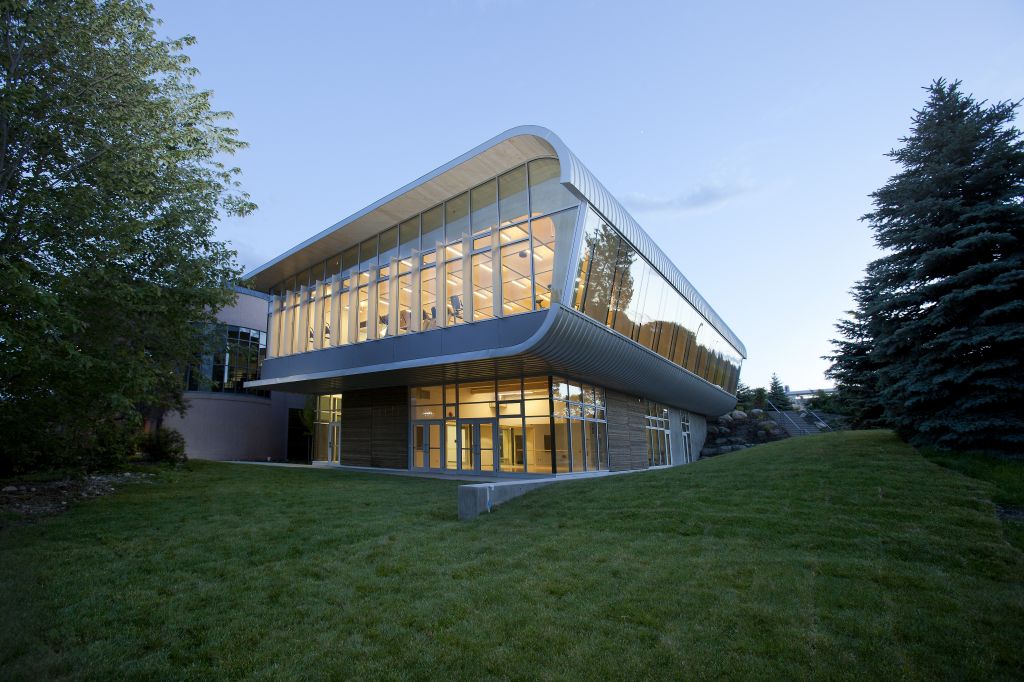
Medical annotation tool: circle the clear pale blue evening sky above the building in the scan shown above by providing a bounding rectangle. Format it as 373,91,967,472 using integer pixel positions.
148,0,1024,388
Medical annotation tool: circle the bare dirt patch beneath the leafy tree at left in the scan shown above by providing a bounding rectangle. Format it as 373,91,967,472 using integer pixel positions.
0,471,154,525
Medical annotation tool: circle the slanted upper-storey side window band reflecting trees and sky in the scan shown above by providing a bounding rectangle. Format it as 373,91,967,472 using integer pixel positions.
572,212,741,394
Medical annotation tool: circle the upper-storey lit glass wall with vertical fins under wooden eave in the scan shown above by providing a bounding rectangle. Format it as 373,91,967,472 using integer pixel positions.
269,159,580,356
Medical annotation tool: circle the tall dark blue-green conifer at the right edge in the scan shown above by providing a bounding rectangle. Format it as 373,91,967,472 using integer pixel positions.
833,80,1024,453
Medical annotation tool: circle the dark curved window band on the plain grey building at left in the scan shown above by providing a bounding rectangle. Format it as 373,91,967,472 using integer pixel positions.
185,325,270,397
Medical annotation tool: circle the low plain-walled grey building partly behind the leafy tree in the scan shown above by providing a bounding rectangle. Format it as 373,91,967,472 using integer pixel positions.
163,288,307,461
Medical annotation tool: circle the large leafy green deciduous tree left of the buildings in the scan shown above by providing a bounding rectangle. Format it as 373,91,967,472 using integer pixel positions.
0,0,254,469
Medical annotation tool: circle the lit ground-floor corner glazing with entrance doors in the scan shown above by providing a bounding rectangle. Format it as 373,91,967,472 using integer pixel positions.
410,377,608,474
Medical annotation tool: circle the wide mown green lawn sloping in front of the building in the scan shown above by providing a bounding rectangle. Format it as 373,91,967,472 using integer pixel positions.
0,432,1024,680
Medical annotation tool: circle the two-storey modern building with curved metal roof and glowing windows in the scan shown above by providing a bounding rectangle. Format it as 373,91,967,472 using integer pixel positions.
246,126,745,476
